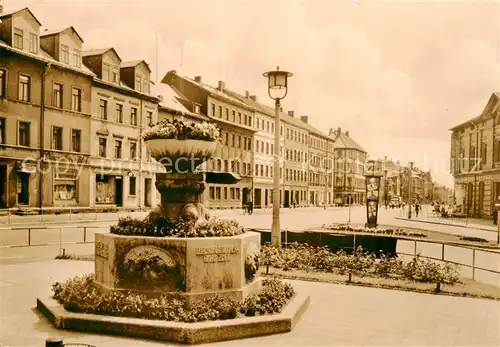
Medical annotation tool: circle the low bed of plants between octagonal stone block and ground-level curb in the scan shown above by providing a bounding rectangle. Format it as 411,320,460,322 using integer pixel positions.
52,275,294,322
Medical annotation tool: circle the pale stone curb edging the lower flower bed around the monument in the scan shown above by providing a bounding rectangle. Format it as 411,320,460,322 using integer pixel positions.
37,294,310,344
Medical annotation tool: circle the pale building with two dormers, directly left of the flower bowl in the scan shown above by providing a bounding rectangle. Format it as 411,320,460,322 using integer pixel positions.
83,48,159,210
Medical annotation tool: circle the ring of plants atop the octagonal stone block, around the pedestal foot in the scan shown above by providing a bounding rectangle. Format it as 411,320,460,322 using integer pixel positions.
110,212,245,237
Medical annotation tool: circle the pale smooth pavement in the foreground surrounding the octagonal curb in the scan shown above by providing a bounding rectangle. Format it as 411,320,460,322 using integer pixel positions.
0,260,500,347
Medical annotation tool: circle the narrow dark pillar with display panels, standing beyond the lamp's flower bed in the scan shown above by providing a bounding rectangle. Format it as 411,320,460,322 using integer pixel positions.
365,160,382,228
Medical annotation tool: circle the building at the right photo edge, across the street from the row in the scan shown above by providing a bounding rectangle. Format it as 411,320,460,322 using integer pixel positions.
450,93,500,217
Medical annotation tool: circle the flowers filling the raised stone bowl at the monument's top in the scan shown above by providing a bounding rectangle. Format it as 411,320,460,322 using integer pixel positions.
142,119,220,141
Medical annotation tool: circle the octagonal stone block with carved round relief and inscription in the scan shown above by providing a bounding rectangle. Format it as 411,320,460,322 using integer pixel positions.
94,232,261,302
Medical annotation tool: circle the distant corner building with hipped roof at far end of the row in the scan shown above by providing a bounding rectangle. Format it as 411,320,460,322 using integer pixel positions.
329,128,366,204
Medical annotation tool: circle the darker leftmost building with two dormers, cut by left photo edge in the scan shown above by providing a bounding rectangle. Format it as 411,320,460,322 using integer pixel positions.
0,8,93,212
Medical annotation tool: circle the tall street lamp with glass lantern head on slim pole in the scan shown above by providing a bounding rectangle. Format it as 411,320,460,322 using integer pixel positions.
263,66,292,247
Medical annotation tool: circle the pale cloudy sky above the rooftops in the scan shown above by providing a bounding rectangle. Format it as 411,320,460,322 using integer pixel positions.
4,0,500,187
